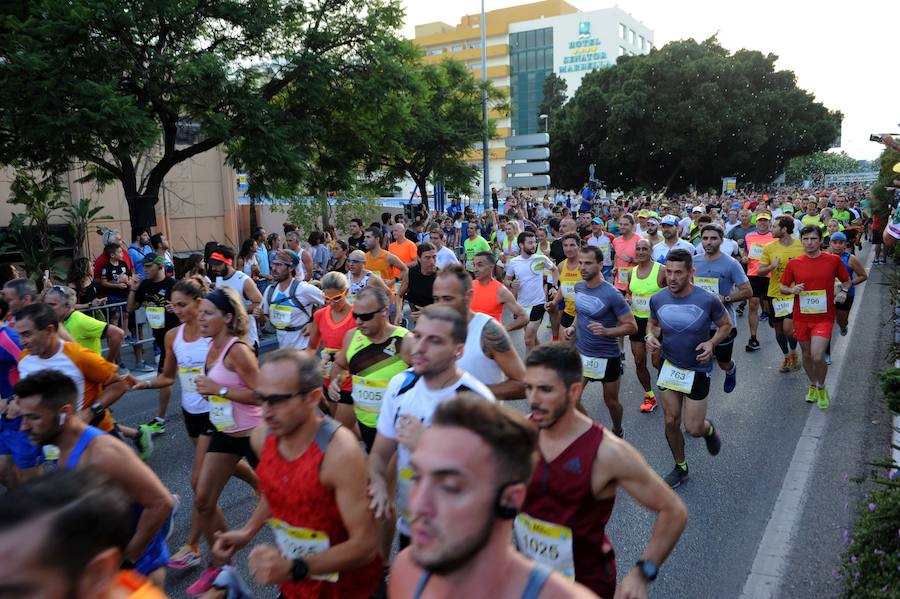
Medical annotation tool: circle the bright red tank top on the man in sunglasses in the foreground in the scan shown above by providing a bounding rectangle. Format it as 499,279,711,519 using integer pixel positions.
256,417,383,599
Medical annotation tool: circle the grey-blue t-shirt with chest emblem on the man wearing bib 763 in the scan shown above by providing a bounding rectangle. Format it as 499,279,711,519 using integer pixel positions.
650,286,725,372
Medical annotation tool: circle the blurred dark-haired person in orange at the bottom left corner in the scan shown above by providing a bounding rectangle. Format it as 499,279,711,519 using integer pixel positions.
0,469,166,599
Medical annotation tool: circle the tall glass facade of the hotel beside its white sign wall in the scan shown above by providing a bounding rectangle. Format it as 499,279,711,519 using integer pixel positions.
509,27,553,135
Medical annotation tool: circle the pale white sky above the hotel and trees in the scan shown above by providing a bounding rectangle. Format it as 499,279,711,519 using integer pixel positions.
402,0,900,160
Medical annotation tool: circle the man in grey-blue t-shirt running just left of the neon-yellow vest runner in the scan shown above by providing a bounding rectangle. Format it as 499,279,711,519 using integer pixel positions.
563,244,637,437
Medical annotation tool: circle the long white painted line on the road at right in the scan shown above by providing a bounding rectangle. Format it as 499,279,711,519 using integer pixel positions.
741,250,873,599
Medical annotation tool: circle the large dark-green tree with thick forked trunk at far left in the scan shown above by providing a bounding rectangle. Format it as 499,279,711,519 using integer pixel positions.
0,0,403,227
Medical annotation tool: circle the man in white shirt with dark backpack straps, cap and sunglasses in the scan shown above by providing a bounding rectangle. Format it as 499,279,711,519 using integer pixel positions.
251,250,325,349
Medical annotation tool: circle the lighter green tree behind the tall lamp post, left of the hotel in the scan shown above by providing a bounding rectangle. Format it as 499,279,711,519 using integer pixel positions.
368,60,506,208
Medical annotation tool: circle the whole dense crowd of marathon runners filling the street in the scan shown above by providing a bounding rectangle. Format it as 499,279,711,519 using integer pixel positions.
0,179,888,599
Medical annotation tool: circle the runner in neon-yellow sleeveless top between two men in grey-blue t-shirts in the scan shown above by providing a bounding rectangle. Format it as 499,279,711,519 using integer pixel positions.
627,239,666,414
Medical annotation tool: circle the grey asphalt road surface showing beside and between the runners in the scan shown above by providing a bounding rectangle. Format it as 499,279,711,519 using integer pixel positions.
107,246,890,598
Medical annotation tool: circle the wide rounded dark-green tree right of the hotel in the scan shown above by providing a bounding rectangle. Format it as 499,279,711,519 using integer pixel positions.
550,38,842,189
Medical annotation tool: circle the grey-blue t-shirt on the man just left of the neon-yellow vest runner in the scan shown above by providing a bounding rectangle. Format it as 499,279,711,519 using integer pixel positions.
575,281,631,358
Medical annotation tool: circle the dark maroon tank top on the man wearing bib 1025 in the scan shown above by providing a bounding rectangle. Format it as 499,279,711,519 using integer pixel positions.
522,423,616,597
